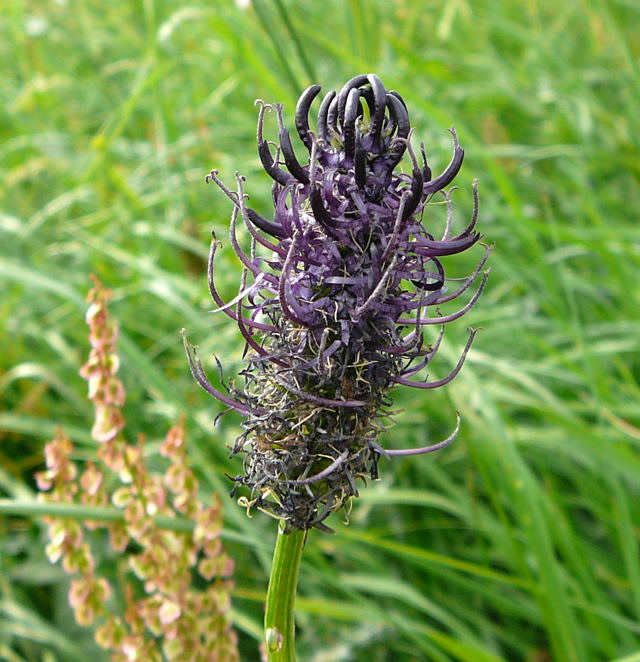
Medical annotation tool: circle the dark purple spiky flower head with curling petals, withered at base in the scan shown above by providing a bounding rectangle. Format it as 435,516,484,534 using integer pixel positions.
187,74,488,529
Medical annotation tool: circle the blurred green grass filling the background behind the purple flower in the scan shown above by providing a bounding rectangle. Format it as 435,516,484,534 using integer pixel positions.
0,0,640,662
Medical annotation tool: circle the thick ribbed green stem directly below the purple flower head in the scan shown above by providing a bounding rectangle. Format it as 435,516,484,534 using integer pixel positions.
264,523,305,662
